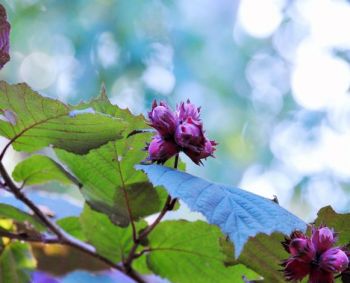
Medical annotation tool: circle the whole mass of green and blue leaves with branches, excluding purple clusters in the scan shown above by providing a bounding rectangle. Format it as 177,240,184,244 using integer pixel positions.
0,72,349,283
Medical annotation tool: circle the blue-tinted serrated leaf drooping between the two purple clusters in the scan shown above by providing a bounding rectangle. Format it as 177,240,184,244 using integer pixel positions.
136,165,306,257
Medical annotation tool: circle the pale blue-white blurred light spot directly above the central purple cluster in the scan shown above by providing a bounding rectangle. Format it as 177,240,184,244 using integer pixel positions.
142,65,175,95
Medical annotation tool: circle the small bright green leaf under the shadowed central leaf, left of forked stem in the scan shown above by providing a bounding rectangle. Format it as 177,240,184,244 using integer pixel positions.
80,205,146,262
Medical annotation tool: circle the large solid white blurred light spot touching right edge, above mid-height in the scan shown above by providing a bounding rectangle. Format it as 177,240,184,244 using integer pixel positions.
292,43,350,110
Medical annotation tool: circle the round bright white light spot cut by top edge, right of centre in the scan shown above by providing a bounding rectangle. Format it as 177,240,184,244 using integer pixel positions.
238,0,284,38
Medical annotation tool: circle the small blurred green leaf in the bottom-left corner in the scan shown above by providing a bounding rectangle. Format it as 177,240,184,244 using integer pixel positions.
0,242,35,283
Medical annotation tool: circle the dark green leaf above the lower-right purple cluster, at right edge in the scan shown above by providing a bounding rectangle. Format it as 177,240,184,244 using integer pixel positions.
315,206,350,246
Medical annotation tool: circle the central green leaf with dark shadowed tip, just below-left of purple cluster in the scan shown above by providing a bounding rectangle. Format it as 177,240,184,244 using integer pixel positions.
56,132,167,227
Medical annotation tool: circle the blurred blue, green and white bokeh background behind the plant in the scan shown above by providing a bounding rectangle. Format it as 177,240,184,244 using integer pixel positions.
0,0,350,282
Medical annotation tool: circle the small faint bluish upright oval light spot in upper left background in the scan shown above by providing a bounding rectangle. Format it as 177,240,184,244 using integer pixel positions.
97,32,120,68
